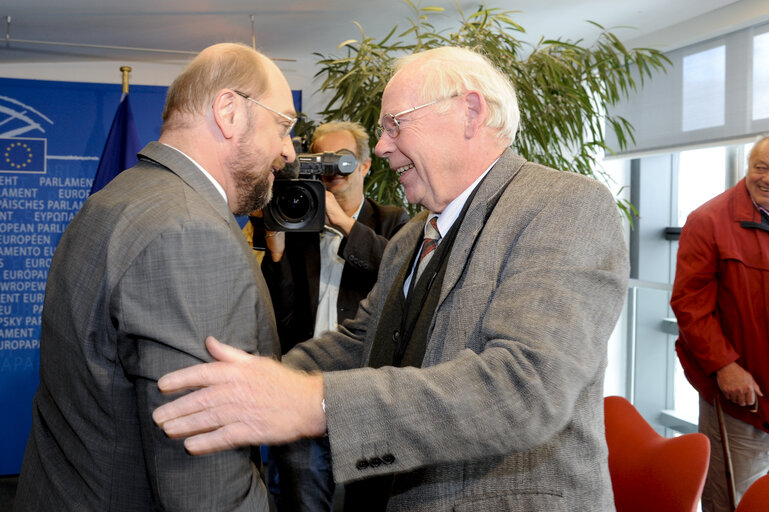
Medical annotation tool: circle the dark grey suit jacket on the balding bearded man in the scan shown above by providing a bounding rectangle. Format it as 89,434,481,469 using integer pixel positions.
15,142,277,511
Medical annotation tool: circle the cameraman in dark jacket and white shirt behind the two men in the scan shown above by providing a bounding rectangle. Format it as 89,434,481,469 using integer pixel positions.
262,121,409,511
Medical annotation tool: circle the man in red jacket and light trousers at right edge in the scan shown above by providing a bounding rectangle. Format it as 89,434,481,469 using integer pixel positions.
670,137,769,512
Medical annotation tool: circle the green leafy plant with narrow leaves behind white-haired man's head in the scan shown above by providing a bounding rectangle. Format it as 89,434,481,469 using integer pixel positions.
308,0,670,218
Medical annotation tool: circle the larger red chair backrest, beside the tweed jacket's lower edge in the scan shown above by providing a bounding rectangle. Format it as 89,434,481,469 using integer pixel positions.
604,396,710,512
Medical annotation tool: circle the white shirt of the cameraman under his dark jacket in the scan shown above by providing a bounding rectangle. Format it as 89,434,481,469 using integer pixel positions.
313,199,365,338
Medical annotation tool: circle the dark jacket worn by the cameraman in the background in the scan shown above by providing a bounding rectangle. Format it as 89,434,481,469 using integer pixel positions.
262,198,409,353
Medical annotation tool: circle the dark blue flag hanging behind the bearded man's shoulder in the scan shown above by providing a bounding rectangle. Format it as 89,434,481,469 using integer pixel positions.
91,94,141,194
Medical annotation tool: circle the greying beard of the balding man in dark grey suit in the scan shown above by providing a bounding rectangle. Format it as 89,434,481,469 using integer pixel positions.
228,135,272,216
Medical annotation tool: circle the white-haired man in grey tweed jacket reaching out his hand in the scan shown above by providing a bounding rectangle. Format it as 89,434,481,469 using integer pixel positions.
154,48,628,512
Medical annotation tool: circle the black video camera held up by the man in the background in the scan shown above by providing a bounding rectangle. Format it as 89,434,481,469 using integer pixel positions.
262,140,358,231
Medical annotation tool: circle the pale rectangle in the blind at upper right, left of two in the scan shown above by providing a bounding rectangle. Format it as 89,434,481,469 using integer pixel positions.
682,46,726,131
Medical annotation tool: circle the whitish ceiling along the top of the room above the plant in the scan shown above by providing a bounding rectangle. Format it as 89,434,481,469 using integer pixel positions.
0,0,766,63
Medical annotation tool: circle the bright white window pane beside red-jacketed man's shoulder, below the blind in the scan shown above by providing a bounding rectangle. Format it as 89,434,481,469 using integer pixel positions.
677,146,726,226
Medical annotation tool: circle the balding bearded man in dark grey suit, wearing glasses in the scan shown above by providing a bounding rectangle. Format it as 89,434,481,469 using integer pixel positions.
15,44,295,512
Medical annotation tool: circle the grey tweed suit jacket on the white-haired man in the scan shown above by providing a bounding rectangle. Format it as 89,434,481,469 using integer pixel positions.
285,146,629,512
